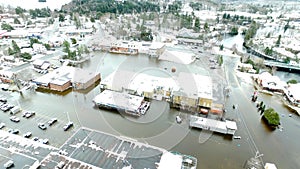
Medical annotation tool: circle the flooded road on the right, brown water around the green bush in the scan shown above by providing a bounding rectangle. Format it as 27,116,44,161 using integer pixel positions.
225,55,300,169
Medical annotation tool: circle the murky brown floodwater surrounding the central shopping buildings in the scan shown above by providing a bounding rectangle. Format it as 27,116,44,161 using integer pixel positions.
10,47,300,169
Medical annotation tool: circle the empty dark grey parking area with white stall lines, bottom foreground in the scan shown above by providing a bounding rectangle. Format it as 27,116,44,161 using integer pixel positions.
41,128,163,169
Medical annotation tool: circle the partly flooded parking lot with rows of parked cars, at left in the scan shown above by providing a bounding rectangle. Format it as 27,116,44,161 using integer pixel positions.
0,91,79,147
